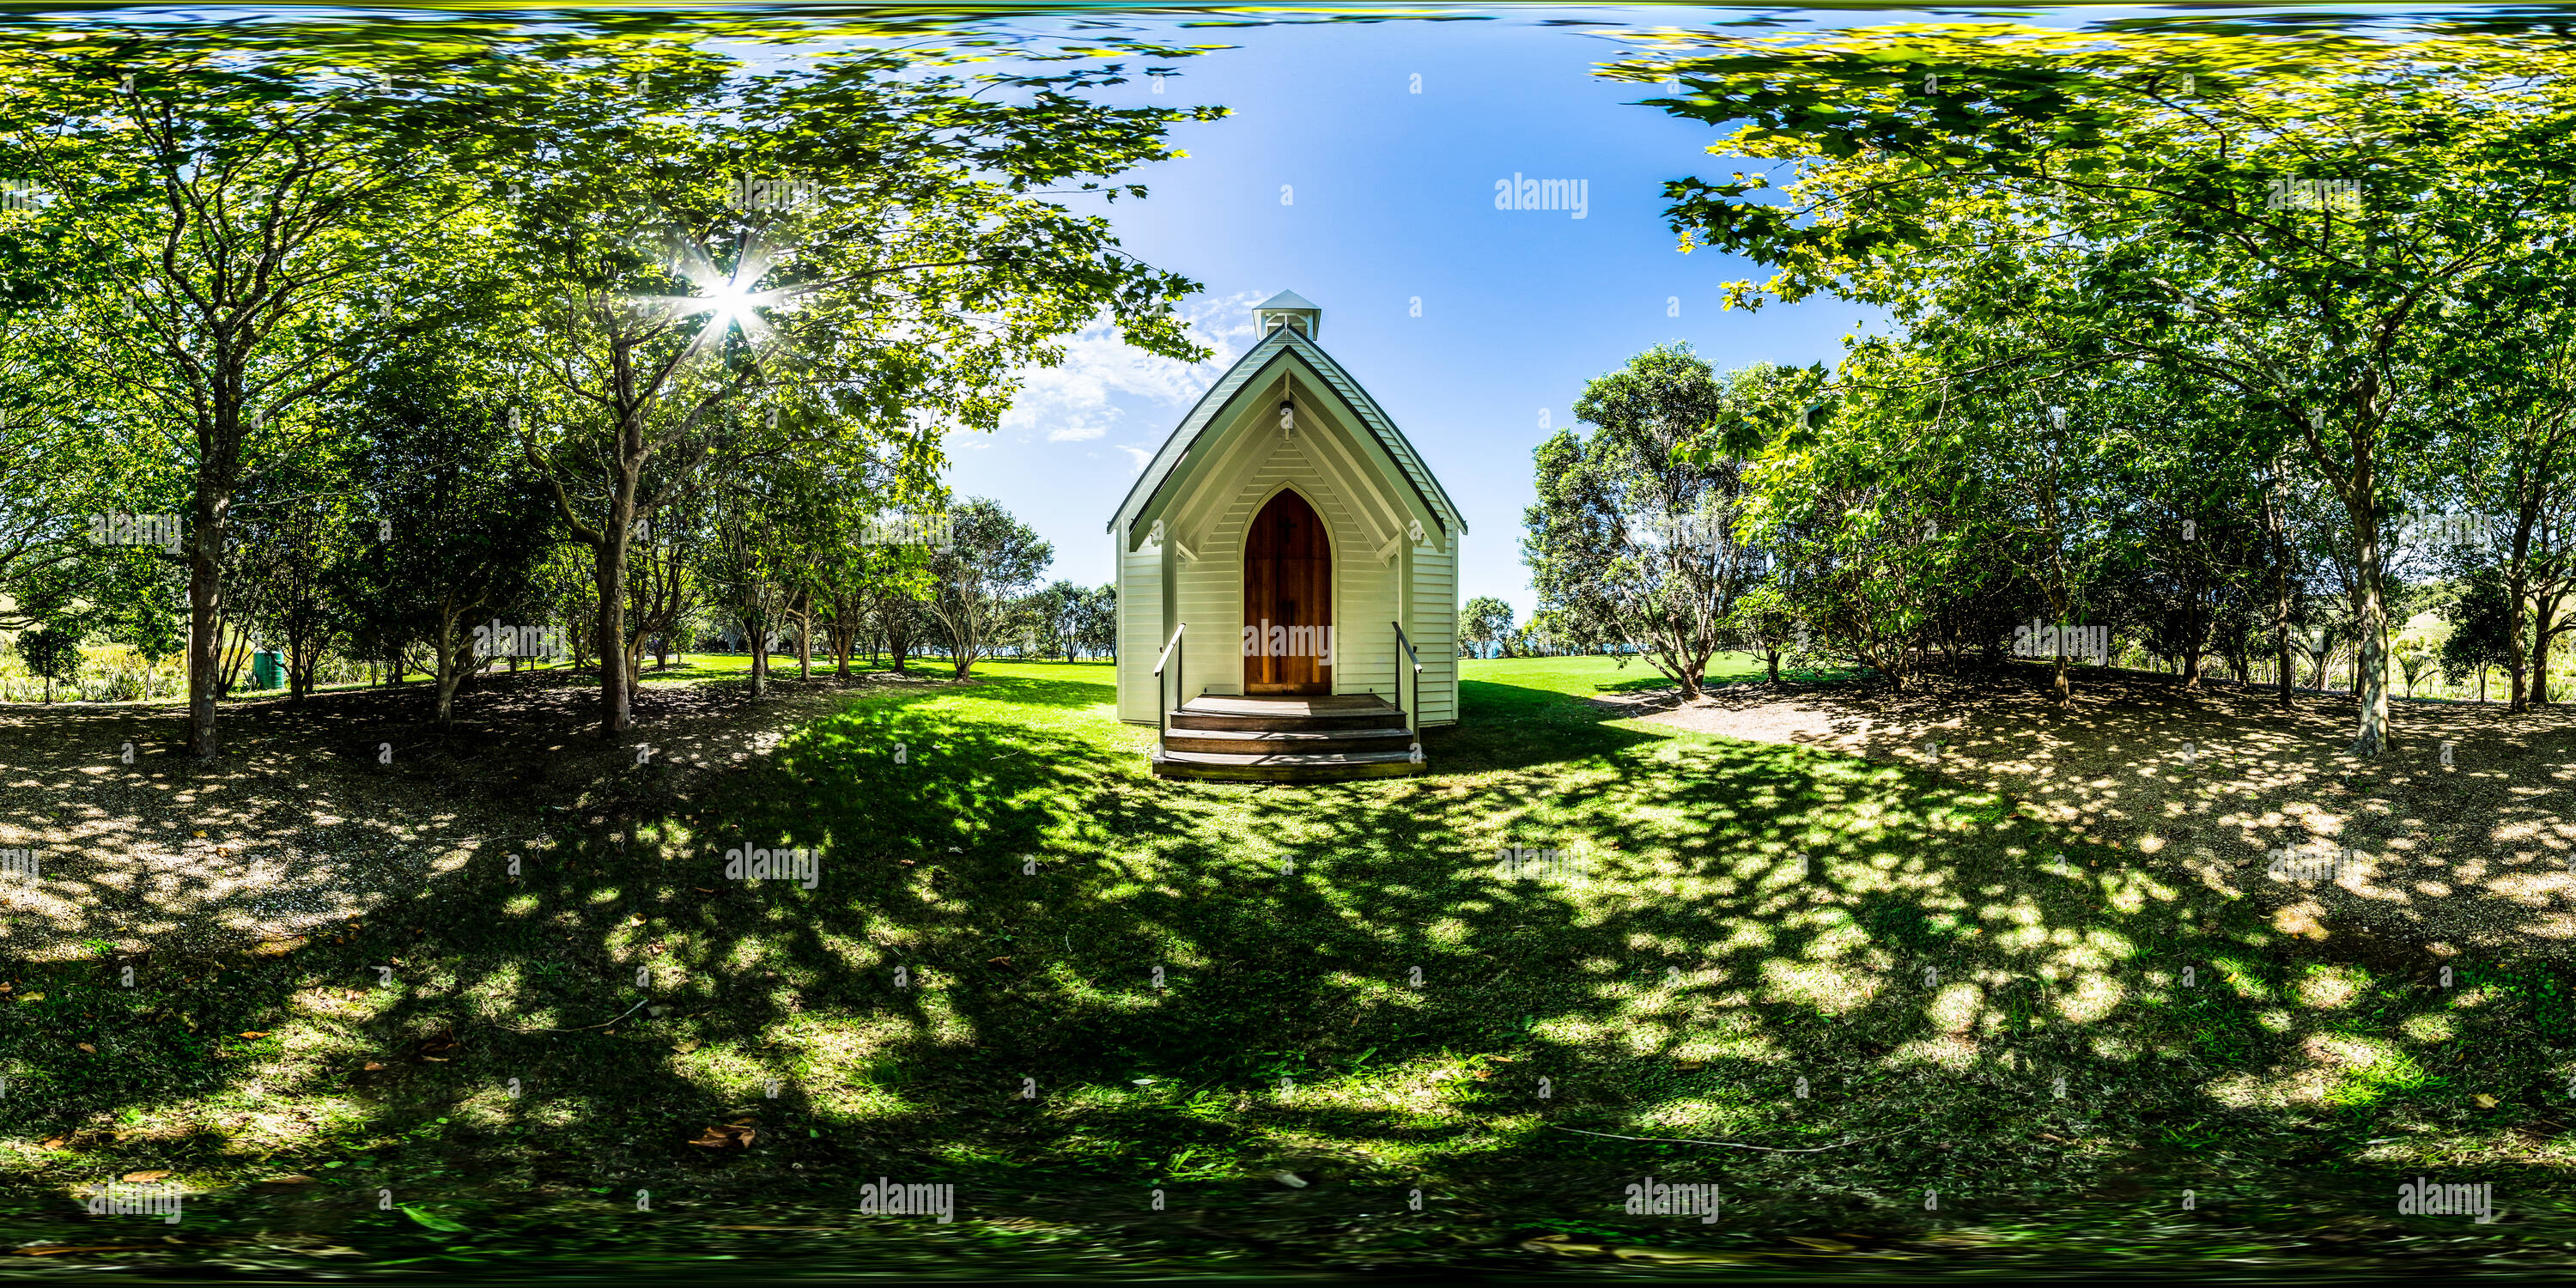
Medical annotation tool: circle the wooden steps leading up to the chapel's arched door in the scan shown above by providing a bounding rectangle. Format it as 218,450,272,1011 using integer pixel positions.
1154,693,1422,783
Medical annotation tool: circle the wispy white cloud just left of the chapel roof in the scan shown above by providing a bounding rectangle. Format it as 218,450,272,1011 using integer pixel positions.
1002,291,1262,448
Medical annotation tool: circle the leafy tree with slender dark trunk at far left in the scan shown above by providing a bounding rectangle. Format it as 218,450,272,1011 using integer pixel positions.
0,42,489,757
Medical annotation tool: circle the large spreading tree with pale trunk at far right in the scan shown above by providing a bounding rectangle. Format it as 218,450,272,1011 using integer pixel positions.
1618,26,2576,755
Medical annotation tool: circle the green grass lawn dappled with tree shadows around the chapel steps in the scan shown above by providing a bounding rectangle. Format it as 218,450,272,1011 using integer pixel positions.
0,659,2576,1275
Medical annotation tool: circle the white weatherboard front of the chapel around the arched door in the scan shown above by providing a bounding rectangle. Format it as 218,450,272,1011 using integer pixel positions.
1110,296,1466,726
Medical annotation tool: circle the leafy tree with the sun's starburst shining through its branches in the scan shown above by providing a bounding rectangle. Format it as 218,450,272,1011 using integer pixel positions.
507,41,1218,737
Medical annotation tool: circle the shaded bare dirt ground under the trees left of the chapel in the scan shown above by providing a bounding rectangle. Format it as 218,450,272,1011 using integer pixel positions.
0,670,938,961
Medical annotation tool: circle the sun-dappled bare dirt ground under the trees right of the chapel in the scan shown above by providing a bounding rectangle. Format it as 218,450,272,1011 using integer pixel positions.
1600,670,2576,953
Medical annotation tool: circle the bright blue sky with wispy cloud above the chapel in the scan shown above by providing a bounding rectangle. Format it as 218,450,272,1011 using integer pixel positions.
948,10,1896,616
